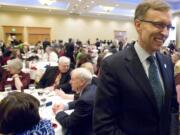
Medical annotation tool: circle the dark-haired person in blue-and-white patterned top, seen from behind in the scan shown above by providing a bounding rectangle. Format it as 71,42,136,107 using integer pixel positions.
0,92,54,135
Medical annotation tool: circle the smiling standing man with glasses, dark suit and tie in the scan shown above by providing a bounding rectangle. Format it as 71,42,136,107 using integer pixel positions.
93,1,178,135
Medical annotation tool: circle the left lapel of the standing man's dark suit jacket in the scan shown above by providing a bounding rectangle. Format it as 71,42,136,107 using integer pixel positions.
125,46,158,113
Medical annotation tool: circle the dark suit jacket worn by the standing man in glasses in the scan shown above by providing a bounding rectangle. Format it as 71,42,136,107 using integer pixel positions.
93,46,178,135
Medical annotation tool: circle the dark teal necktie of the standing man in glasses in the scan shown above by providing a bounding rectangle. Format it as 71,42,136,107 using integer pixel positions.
147,56,164,111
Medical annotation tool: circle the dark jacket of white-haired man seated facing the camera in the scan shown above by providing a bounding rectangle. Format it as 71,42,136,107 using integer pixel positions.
39,67,72,93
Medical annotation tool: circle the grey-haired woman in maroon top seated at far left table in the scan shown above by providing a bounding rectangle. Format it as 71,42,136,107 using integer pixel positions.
0,59,30,91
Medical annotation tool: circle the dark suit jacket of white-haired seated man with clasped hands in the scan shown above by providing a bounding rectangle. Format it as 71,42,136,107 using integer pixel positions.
56,85,96,135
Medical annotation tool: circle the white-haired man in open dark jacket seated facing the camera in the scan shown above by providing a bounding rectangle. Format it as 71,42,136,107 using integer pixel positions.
39,56,72,93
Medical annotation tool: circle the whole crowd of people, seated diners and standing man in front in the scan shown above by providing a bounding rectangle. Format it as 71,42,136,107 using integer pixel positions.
0,1,180,135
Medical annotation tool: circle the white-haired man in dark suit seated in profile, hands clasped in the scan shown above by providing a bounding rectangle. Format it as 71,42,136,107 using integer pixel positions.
53,68,96,135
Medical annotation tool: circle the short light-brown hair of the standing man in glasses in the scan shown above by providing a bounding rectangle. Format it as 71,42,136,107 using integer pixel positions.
134,0,170,20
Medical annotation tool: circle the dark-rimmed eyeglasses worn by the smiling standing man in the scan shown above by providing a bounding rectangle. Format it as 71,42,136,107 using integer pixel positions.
140,20,175,30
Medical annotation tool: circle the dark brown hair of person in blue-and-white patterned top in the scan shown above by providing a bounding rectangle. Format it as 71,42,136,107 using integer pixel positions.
0,92,40,134
